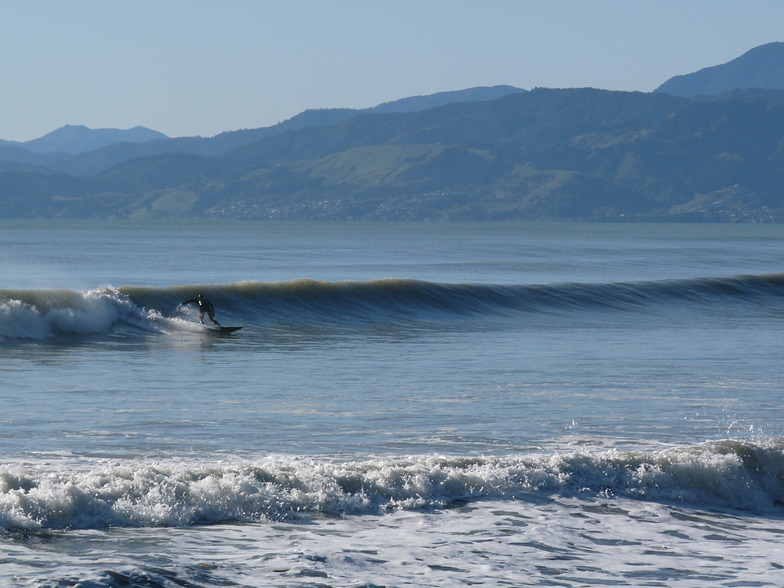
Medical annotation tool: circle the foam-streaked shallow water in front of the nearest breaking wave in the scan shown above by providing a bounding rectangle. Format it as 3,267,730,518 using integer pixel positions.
0,497,781,588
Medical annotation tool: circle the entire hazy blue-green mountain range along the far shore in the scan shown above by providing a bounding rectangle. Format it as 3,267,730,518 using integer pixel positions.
0,43,784,222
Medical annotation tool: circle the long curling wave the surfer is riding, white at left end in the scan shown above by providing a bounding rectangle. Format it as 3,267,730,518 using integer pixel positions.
0,274,784,340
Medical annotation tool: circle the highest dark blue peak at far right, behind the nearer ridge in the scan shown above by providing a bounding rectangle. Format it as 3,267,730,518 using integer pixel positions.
655,43,784,97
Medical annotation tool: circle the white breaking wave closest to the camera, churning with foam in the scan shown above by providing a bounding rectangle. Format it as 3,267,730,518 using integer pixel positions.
0,439,784,530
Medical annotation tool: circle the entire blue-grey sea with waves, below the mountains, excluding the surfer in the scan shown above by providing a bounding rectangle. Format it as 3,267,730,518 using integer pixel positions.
0,221,784,587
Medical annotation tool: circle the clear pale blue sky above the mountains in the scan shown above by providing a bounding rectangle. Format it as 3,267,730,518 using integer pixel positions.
0,0,784,141
